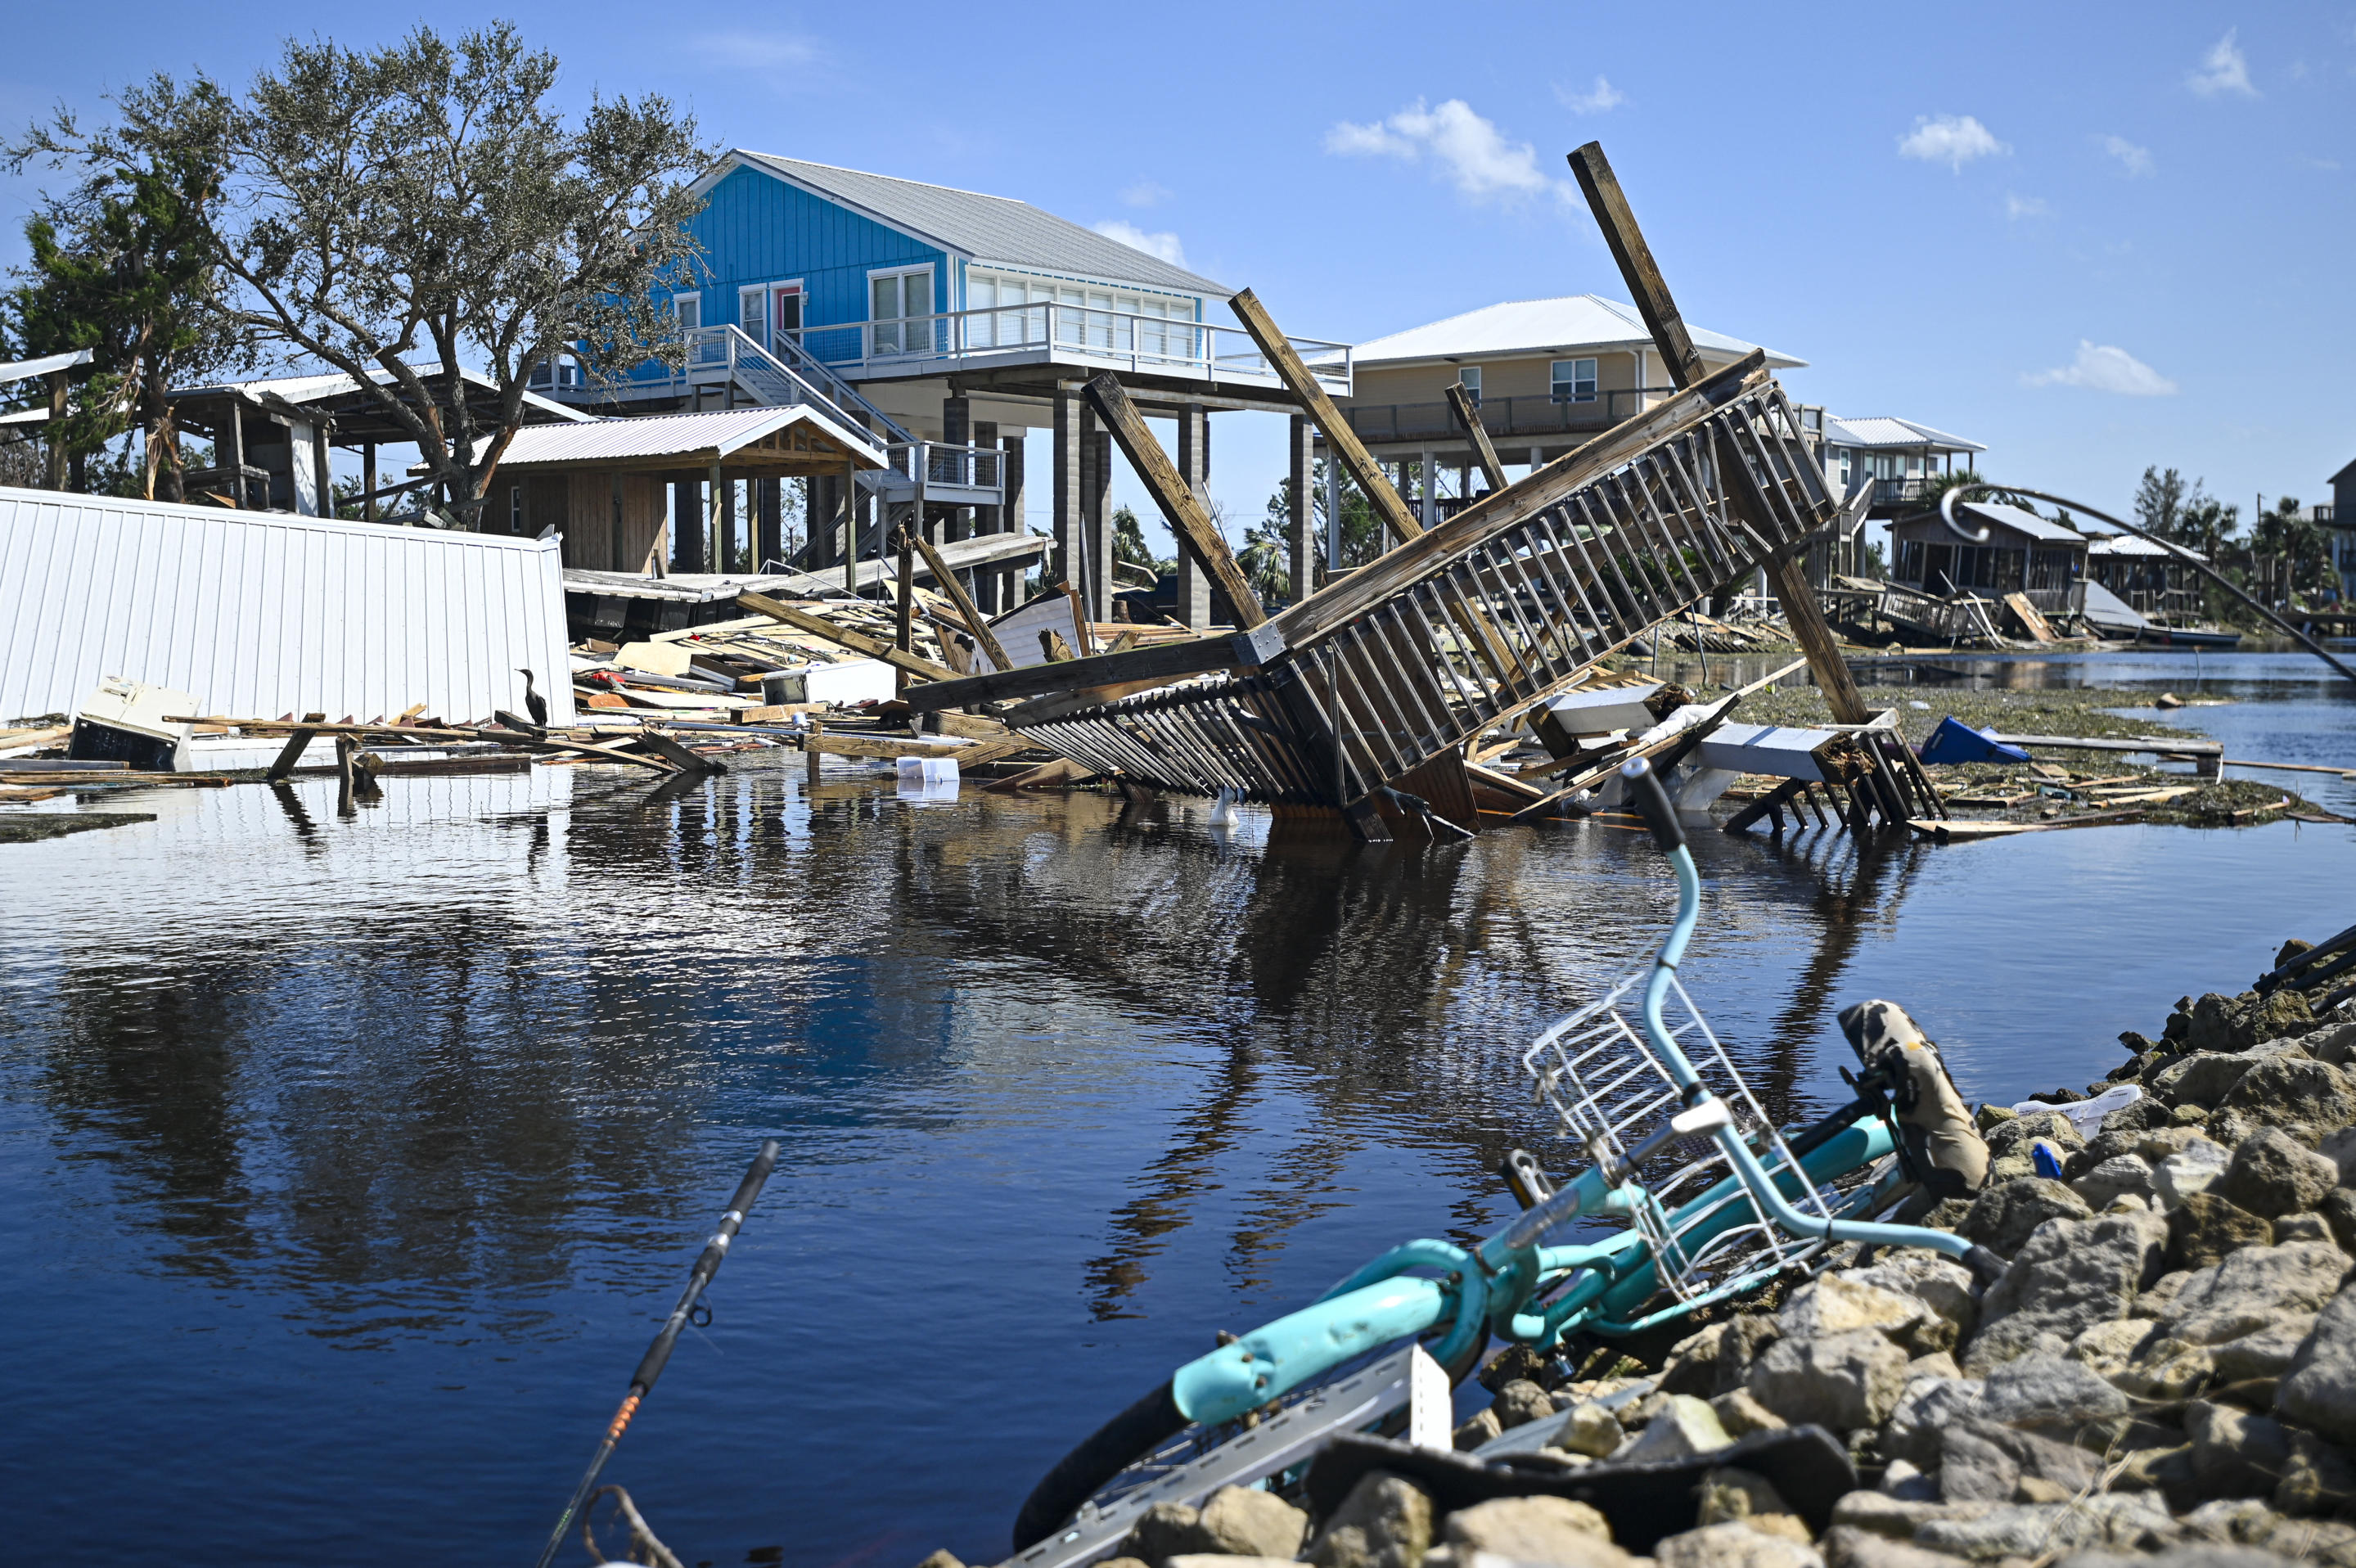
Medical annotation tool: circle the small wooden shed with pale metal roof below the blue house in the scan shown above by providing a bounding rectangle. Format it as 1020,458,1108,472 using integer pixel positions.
495,403,886,577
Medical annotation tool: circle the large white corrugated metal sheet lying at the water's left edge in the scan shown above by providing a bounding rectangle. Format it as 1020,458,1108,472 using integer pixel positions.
0,488,573,723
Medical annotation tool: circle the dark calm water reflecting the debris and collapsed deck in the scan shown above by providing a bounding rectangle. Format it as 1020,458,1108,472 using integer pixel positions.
0,655,2356,1568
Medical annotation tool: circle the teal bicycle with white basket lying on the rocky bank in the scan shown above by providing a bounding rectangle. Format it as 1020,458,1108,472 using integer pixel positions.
1013,758,2005,1568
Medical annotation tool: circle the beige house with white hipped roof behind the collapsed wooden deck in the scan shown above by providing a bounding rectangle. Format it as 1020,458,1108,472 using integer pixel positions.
1317,295,1807,525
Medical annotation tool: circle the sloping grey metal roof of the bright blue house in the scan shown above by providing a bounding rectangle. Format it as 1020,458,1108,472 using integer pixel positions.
716,148,1235,299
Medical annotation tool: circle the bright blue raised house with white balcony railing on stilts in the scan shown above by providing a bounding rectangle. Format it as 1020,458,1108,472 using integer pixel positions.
542,148,1350,624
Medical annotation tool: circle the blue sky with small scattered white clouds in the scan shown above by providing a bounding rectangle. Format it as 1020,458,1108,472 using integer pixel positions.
0,0,2356,536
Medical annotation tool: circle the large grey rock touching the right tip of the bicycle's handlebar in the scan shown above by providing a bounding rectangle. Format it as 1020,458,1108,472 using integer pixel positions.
1962,1196,2168,1372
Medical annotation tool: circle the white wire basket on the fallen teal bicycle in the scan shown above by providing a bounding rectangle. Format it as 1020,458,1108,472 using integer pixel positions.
1522,970,1828,1302
